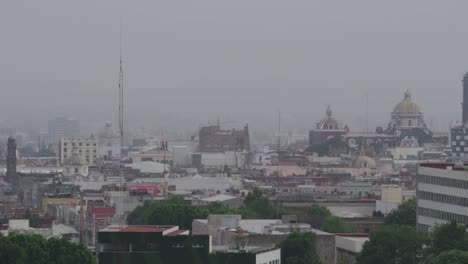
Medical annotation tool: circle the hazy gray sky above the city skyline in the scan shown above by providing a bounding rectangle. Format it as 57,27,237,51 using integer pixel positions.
0,0,468,130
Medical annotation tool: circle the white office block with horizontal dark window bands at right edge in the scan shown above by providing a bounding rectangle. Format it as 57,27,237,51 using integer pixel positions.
416,163,468,231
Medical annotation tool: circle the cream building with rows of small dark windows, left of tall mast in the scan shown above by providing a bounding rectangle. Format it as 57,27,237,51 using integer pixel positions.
59,138,99,166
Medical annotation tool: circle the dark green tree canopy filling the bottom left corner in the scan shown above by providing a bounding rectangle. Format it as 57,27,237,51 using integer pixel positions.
0,234,96,264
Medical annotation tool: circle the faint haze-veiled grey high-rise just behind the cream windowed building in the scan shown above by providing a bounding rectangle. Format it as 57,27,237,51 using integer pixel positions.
49,117,79,144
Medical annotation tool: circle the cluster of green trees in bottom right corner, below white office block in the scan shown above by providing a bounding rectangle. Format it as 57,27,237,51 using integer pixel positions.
357,199,468,264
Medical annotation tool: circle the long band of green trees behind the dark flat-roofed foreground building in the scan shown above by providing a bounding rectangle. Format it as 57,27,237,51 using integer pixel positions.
127,189,356,233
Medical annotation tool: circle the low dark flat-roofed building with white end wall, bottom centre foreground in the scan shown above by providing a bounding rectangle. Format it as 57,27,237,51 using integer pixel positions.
98,225,281,264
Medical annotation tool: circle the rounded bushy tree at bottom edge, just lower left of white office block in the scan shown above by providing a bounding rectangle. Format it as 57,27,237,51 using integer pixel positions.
357,225,427,264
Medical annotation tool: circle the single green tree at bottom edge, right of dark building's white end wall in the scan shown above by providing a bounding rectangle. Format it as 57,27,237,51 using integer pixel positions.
280,232,320,264
